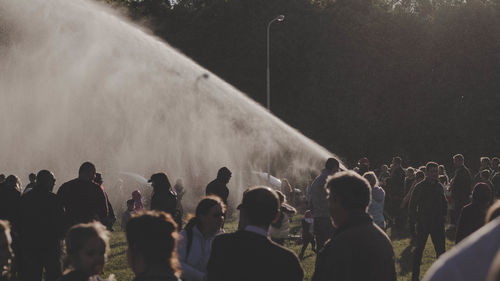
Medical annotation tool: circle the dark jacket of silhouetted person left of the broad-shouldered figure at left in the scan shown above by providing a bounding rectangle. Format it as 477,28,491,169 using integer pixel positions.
19,187,63,250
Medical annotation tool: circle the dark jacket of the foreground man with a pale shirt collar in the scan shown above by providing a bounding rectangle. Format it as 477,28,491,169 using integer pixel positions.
207,230,304,281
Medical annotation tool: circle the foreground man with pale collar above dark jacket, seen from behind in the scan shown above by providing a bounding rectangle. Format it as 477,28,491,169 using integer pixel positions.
207,186,304,281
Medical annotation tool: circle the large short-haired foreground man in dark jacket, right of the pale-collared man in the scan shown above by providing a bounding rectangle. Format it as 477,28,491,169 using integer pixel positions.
312,171,396,281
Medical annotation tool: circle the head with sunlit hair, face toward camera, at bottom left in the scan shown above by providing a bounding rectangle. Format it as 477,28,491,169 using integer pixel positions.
64,222,109,276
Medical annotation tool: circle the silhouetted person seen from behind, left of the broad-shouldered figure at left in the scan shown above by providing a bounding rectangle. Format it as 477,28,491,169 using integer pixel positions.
19,170,63,281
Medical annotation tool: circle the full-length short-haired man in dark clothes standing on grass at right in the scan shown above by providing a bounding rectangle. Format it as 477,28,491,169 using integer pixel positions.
409,162,448,280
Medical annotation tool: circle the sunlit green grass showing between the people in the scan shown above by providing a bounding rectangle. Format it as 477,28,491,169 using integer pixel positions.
105,212,454,281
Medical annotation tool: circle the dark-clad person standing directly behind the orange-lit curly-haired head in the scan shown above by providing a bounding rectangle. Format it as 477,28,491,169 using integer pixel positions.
148,173,178,219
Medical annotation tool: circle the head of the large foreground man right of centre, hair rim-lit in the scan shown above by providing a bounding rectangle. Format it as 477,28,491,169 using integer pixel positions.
326,171,371,227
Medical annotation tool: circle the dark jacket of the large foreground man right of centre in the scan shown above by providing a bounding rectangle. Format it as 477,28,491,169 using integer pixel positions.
312,212,396,281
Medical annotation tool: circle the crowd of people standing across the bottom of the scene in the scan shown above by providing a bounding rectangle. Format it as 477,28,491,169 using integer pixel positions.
0,154,500,281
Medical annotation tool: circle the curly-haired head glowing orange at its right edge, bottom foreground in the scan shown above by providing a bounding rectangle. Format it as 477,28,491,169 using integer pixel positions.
125,211,179,276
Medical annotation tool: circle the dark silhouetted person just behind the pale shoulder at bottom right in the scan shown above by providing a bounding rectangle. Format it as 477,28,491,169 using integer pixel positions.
455,183,492,244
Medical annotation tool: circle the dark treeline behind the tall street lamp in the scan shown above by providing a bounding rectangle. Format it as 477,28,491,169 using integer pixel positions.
103,0,500,167
